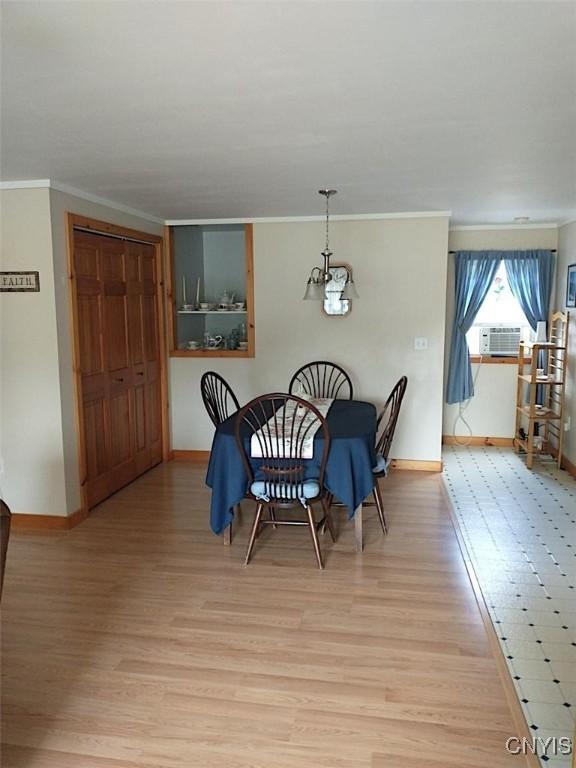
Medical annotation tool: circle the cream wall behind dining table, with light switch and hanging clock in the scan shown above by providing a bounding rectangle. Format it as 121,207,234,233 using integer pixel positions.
170,217,448,461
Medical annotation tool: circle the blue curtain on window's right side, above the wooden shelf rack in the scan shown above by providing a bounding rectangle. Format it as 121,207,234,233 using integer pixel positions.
502,251,554,331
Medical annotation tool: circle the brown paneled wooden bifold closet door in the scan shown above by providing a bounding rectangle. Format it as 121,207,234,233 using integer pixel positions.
74,232,162,506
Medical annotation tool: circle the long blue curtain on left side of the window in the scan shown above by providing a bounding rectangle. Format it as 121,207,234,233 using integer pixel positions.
446,251,504,403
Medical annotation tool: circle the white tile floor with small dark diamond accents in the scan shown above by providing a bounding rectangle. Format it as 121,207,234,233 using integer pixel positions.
443,446,576,768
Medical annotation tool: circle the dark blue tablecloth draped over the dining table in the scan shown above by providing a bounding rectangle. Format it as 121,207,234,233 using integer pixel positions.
206,400,376,533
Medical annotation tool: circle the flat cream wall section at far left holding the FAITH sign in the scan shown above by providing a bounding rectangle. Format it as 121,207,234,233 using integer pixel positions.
0,189,67,515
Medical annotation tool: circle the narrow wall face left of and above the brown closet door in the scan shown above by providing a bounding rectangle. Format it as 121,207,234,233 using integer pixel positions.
45,189,163,515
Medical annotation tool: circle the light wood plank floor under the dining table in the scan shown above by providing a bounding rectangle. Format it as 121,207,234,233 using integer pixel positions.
2,463,524,768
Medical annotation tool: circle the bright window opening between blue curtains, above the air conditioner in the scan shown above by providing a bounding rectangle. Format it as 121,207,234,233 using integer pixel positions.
466,262,533,355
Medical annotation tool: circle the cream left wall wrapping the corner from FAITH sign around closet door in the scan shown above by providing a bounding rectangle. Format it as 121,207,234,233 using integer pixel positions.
0,189,162,516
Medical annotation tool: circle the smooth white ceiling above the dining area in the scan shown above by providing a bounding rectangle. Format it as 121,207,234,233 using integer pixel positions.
1,0,576,224
